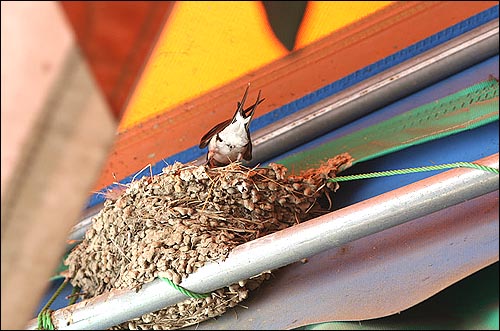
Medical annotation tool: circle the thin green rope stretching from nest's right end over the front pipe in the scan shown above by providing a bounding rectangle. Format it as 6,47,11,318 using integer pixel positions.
329,162,498,182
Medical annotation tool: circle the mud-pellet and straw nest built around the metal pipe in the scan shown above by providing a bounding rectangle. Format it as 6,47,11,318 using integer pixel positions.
65,154,352,330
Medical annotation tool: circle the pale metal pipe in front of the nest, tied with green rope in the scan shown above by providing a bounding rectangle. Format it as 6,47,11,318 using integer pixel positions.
24,153,498,329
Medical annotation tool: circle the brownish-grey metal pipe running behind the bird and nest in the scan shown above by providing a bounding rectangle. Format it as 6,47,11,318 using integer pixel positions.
69,20,499,244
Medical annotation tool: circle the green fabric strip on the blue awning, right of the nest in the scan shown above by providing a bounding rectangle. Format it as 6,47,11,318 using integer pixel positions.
280,80,499,171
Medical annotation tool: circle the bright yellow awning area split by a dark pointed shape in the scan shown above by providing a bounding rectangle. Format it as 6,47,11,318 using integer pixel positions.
119,1,391,131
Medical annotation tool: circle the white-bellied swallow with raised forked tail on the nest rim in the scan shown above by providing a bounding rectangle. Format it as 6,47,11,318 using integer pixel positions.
199,83,265,168
